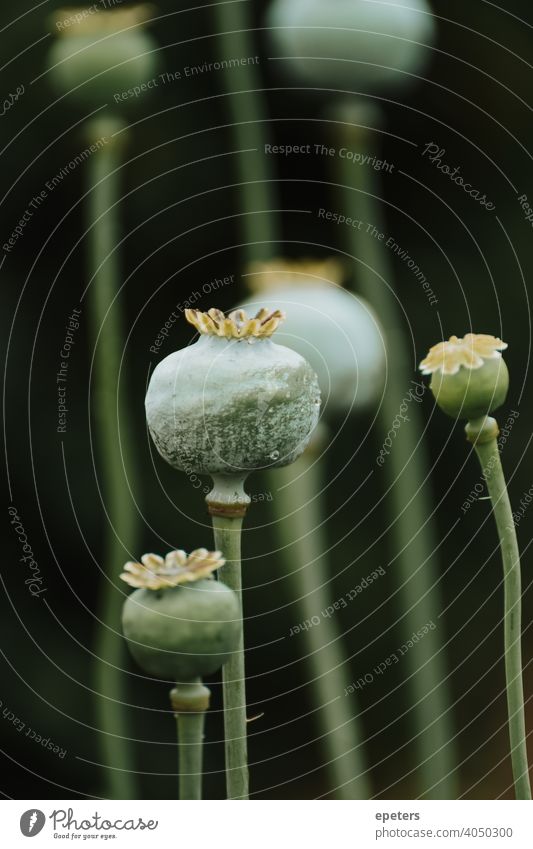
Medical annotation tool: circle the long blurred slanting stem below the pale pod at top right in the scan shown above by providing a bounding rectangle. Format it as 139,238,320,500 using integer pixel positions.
334,103,457,799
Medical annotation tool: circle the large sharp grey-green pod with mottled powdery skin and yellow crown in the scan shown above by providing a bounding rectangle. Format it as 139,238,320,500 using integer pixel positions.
146,309,320,478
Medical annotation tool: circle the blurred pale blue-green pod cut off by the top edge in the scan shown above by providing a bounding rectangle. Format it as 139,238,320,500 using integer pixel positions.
266,0,435,92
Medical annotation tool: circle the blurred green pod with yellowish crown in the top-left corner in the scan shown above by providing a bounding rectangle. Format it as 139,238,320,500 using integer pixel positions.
49,4,158,108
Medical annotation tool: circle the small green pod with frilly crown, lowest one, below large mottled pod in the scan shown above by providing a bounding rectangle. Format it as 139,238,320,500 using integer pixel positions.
121,549,240,682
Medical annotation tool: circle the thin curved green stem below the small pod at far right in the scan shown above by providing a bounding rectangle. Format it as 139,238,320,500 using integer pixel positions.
467,418,531,799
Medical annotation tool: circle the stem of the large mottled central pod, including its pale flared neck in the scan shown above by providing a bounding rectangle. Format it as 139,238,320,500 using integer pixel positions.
206,477,250,799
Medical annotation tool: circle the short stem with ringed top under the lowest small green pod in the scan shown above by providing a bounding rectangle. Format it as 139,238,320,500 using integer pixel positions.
170,678,211,801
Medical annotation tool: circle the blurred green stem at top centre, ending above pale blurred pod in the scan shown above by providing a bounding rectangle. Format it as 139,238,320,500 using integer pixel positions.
213,2,280,263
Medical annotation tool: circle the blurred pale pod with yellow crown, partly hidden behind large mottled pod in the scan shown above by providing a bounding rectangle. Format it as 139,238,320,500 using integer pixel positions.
239,260,385,417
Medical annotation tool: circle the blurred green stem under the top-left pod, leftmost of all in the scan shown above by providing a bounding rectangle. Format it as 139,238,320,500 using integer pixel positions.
87,117,138,799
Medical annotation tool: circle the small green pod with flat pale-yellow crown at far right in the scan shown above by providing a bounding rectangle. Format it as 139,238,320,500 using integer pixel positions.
420,333,509,419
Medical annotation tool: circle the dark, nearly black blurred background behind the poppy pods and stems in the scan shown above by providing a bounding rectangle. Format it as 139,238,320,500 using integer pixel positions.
0,0,533,799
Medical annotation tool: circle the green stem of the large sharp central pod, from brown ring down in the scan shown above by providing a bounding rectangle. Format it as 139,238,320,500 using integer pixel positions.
212,494,249,799
